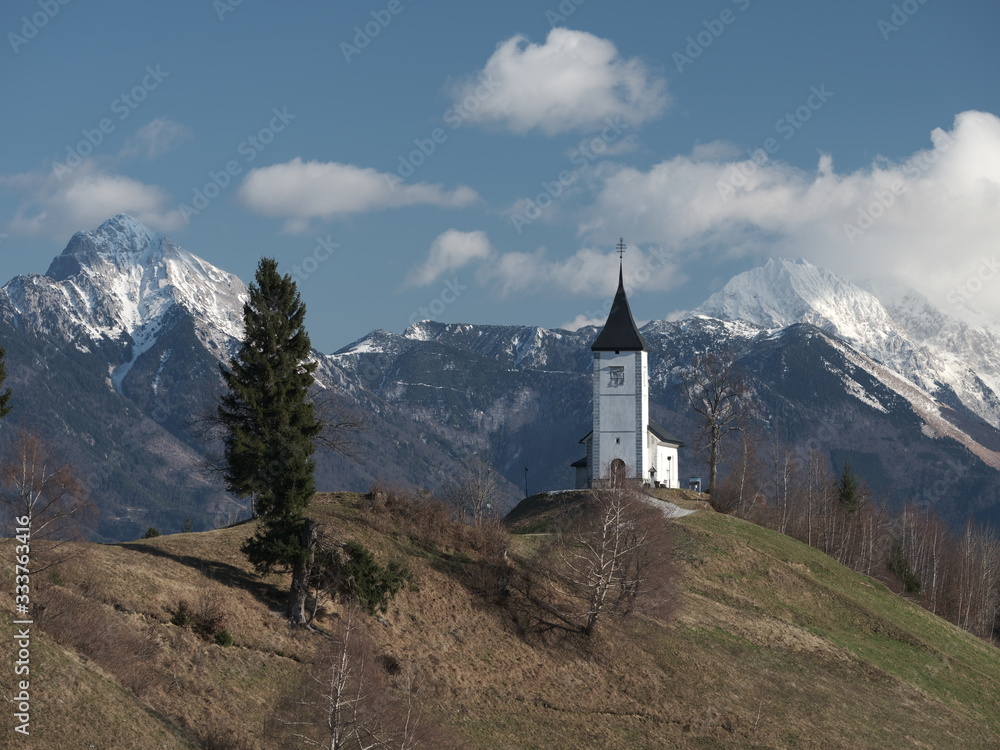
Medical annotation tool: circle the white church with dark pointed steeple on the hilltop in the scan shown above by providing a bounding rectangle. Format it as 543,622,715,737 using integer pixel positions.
572,241,684,489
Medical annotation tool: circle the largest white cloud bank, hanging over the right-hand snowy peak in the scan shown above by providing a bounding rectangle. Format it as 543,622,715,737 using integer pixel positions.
580,111,1000,314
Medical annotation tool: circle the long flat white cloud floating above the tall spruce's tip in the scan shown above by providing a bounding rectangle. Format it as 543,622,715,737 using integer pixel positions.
239,157,479,232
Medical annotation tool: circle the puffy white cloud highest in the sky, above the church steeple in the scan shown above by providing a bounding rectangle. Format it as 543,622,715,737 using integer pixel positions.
453,28,668,135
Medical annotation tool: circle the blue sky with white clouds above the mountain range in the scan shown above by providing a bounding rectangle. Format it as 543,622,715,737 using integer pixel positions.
0,0,1000,351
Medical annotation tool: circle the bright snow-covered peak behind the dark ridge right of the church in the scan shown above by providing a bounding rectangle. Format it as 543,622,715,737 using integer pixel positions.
693,259,1000,427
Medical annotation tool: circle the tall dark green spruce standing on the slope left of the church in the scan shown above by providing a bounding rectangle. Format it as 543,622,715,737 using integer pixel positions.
218,258,322,623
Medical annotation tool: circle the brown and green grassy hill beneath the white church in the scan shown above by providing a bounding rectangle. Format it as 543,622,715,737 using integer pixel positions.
0,493,1000,750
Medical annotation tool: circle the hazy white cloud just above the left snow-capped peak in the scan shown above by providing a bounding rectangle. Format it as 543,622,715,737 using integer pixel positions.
0,160,185,240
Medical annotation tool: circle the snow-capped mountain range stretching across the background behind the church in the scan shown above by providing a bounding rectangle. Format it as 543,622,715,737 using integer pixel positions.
0,215,1000,540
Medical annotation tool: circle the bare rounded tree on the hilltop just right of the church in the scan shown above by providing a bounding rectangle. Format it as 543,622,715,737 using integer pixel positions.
681,351,752,495
